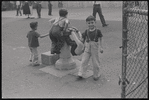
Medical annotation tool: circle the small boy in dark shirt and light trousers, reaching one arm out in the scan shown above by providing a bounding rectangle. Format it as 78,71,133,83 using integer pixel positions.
27,22,49,66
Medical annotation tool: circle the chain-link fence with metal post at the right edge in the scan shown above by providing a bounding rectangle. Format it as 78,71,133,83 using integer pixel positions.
121,1,148,98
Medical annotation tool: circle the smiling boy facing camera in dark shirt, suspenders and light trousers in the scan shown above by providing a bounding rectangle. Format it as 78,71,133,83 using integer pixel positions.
77,15,103,81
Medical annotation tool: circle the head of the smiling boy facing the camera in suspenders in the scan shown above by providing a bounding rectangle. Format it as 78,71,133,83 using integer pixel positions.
86,15,96,29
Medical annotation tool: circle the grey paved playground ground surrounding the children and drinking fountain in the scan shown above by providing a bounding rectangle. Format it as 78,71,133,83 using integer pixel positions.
2,8,122,98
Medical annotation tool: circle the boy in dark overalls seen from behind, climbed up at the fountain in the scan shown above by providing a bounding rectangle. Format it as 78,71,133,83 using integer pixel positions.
49,8,70,54
